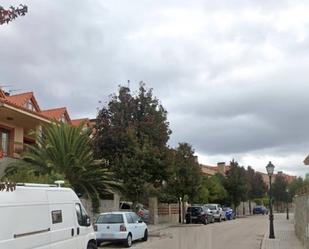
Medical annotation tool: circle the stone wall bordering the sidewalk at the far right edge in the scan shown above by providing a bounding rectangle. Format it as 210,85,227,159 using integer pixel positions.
294,196,309,249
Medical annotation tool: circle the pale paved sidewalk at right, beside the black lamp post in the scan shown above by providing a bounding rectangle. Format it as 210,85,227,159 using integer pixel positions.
261,214,305,249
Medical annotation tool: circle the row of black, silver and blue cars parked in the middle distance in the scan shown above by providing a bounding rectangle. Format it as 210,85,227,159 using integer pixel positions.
185,204,235,225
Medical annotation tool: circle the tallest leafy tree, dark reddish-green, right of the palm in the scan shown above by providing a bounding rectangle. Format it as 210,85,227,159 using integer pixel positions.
94,83,171,202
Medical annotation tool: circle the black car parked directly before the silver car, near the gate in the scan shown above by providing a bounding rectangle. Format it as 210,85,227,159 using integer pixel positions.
186,205,213,225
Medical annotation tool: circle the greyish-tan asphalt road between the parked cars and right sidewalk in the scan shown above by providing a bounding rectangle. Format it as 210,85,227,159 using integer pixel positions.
102,215,268,249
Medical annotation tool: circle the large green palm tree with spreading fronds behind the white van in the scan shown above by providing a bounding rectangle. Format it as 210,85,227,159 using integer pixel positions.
6,123,120,209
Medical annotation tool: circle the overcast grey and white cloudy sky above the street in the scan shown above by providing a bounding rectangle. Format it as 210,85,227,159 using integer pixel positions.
0,0,309,175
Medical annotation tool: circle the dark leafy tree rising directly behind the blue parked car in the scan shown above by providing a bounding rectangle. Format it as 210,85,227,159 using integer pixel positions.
224,160,248,208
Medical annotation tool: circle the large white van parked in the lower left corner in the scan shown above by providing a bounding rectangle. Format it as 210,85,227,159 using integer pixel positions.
0,184,97,249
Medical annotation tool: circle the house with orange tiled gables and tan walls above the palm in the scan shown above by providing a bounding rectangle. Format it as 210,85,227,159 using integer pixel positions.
0,89,88,176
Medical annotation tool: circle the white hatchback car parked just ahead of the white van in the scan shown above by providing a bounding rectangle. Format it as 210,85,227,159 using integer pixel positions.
94,212,148,247
